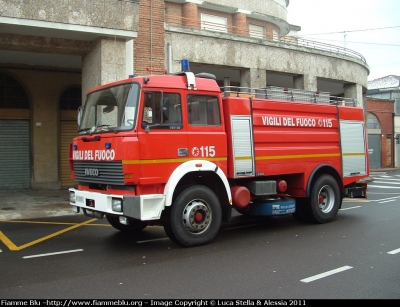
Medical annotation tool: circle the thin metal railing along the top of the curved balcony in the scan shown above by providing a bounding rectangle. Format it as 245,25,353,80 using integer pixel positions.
165,14,367,63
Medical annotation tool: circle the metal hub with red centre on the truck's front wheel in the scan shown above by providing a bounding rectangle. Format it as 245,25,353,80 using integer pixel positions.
182,201,211,233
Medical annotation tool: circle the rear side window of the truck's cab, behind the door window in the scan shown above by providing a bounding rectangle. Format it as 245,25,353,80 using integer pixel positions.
187,95,221,126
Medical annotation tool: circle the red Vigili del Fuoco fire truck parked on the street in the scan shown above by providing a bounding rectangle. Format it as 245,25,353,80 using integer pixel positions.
69,72,369,247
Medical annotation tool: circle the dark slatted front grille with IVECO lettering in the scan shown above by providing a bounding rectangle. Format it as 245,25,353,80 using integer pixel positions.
74,161,124,185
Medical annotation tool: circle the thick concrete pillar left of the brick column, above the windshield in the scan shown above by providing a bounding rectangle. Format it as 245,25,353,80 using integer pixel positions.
82,37,126,101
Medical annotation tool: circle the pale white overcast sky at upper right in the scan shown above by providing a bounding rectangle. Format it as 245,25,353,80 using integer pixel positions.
287,0,400,81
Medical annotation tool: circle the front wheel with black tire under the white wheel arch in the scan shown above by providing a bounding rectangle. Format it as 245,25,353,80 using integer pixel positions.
163,185,222,247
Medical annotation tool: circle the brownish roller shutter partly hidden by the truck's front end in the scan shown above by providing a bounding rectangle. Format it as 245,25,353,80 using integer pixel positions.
60,120,78,187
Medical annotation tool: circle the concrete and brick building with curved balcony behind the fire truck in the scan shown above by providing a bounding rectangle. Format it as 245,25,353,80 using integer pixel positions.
0,0,369,189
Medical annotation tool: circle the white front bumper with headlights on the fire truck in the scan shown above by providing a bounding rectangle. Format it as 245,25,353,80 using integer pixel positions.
69,188,165,221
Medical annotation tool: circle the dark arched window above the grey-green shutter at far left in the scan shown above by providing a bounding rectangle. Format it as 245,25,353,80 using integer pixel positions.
0,74,29,109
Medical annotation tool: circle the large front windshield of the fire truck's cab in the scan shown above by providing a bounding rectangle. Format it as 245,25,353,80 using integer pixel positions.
79,83,139,133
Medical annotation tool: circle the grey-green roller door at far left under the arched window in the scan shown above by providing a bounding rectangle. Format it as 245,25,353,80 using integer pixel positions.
0,119,31,190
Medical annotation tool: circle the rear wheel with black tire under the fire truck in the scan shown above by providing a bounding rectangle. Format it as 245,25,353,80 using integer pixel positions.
293,175,342,224
